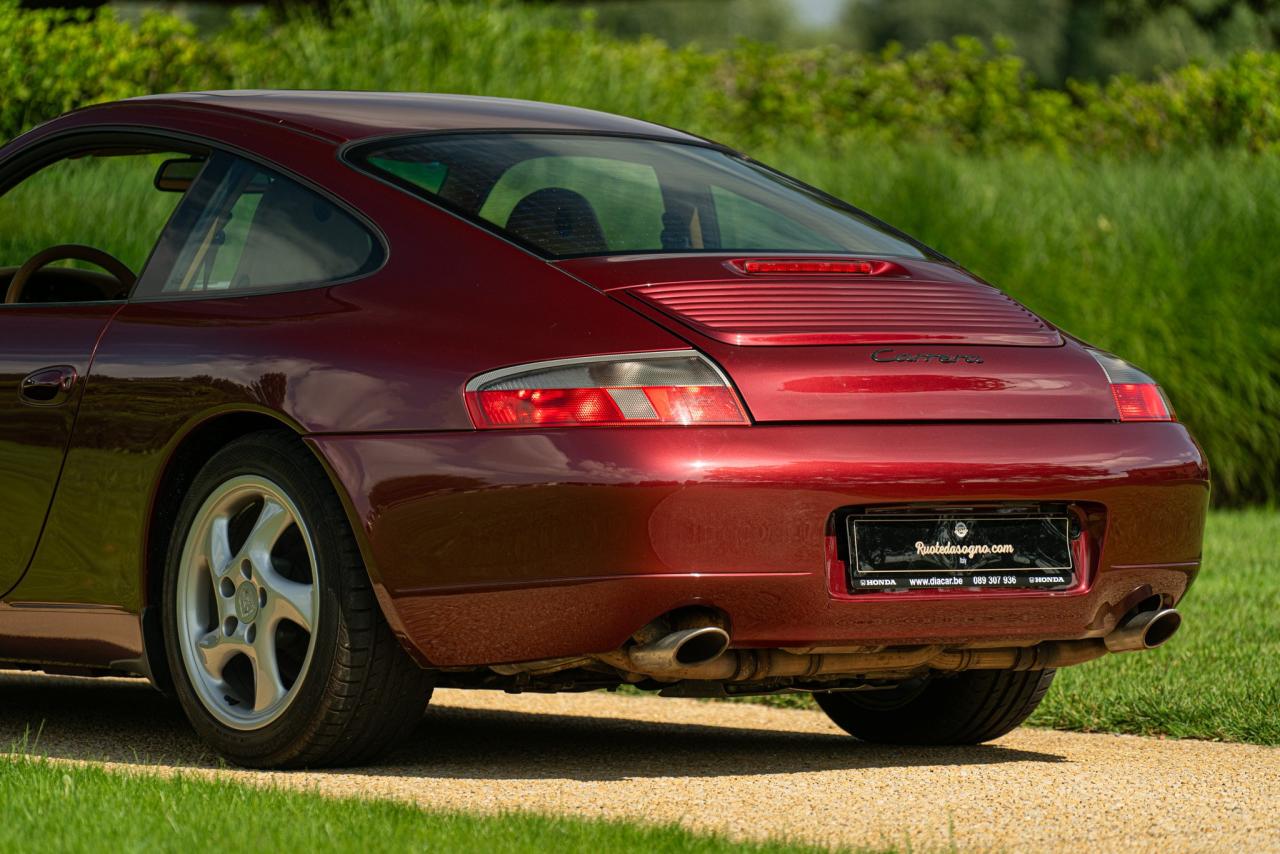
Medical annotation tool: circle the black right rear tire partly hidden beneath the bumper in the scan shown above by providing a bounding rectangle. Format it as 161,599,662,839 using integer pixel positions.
813,670,1055,744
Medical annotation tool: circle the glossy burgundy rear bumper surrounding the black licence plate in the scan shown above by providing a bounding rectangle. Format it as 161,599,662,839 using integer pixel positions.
310,423,1208,666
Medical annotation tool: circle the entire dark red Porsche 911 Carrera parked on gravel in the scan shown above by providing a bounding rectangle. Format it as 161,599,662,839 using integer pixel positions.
0,92,1208,767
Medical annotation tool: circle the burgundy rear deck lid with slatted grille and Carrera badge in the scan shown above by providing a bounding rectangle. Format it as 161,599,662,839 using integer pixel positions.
558,255,1116,421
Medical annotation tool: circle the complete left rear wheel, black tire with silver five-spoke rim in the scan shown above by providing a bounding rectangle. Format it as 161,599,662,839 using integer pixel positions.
164,433,431,767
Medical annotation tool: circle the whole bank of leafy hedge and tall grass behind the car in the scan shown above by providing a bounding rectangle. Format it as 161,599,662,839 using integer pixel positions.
0,0,1280,503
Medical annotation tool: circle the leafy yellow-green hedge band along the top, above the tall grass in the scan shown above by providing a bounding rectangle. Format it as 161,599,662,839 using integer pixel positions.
0,0,1280,155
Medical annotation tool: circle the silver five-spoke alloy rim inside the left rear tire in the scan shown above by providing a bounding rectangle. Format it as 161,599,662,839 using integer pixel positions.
174,475,320,730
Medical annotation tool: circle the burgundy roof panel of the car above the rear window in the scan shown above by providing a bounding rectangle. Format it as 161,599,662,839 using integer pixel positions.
110,90,703,142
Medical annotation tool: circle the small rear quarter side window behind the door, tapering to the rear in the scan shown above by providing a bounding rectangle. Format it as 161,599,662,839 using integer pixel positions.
141,152,383,297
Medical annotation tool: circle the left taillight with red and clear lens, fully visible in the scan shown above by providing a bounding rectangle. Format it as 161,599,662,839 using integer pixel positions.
466,351,749,429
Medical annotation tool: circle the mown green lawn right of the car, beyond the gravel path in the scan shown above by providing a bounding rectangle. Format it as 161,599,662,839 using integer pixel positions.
751,510,1280,745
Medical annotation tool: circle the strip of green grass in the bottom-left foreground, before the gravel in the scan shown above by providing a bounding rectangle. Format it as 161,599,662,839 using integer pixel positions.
0,755,844,854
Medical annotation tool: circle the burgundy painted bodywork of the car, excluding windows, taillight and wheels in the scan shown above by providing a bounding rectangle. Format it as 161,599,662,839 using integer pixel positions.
0,93,1208,681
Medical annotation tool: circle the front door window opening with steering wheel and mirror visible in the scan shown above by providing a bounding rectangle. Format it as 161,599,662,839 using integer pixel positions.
0,143,200,303
